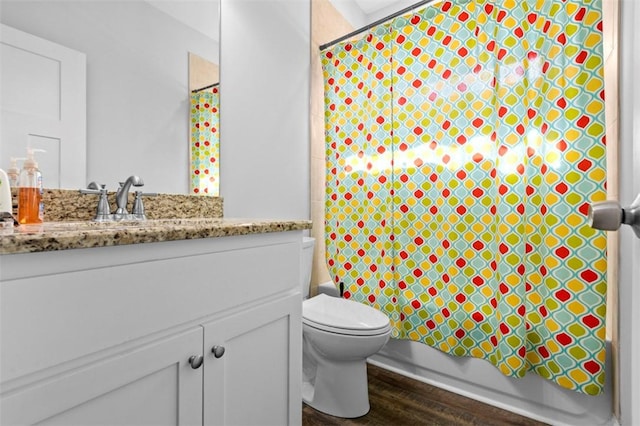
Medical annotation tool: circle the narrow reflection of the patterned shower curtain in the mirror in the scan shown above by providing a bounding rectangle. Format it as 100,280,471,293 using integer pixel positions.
190,86,220,196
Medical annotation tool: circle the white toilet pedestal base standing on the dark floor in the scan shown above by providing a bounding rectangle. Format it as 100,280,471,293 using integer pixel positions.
302,359,370,419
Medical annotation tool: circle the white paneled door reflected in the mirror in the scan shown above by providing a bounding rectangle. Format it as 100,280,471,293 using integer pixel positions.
0,25,87,189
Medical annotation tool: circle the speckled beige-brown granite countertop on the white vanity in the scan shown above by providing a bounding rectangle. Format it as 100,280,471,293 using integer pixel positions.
0,218,311,254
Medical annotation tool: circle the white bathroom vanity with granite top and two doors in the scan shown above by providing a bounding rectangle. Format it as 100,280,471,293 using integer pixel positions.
0,219,311,425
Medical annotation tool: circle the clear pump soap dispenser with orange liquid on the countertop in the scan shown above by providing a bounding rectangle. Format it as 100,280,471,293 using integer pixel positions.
18,148,44,224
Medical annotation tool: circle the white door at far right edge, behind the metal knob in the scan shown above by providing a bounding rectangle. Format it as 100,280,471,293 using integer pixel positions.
619,0,640,425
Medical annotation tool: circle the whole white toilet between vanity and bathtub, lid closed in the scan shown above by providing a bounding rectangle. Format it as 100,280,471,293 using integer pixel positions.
301,237,391,418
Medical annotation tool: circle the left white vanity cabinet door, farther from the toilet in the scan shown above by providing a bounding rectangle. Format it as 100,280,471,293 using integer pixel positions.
1,327,203,426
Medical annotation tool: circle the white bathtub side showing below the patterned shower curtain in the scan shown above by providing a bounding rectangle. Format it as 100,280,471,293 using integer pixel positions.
369,339,618,426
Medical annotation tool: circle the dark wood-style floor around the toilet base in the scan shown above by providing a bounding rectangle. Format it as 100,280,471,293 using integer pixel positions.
302,364,544,426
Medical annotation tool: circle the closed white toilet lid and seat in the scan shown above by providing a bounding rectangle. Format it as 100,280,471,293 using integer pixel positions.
302,294,390,335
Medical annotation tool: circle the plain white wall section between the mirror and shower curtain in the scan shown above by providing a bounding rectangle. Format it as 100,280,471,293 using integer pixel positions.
220,0,311,219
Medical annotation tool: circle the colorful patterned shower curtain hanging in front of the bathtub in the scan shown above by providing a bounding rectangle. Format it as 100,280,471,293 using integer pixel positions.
322,0,606,395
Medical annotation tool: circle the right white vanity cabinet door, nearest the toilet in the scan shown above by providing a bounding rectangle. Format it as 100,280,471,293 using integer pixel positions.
204,293,302,425
